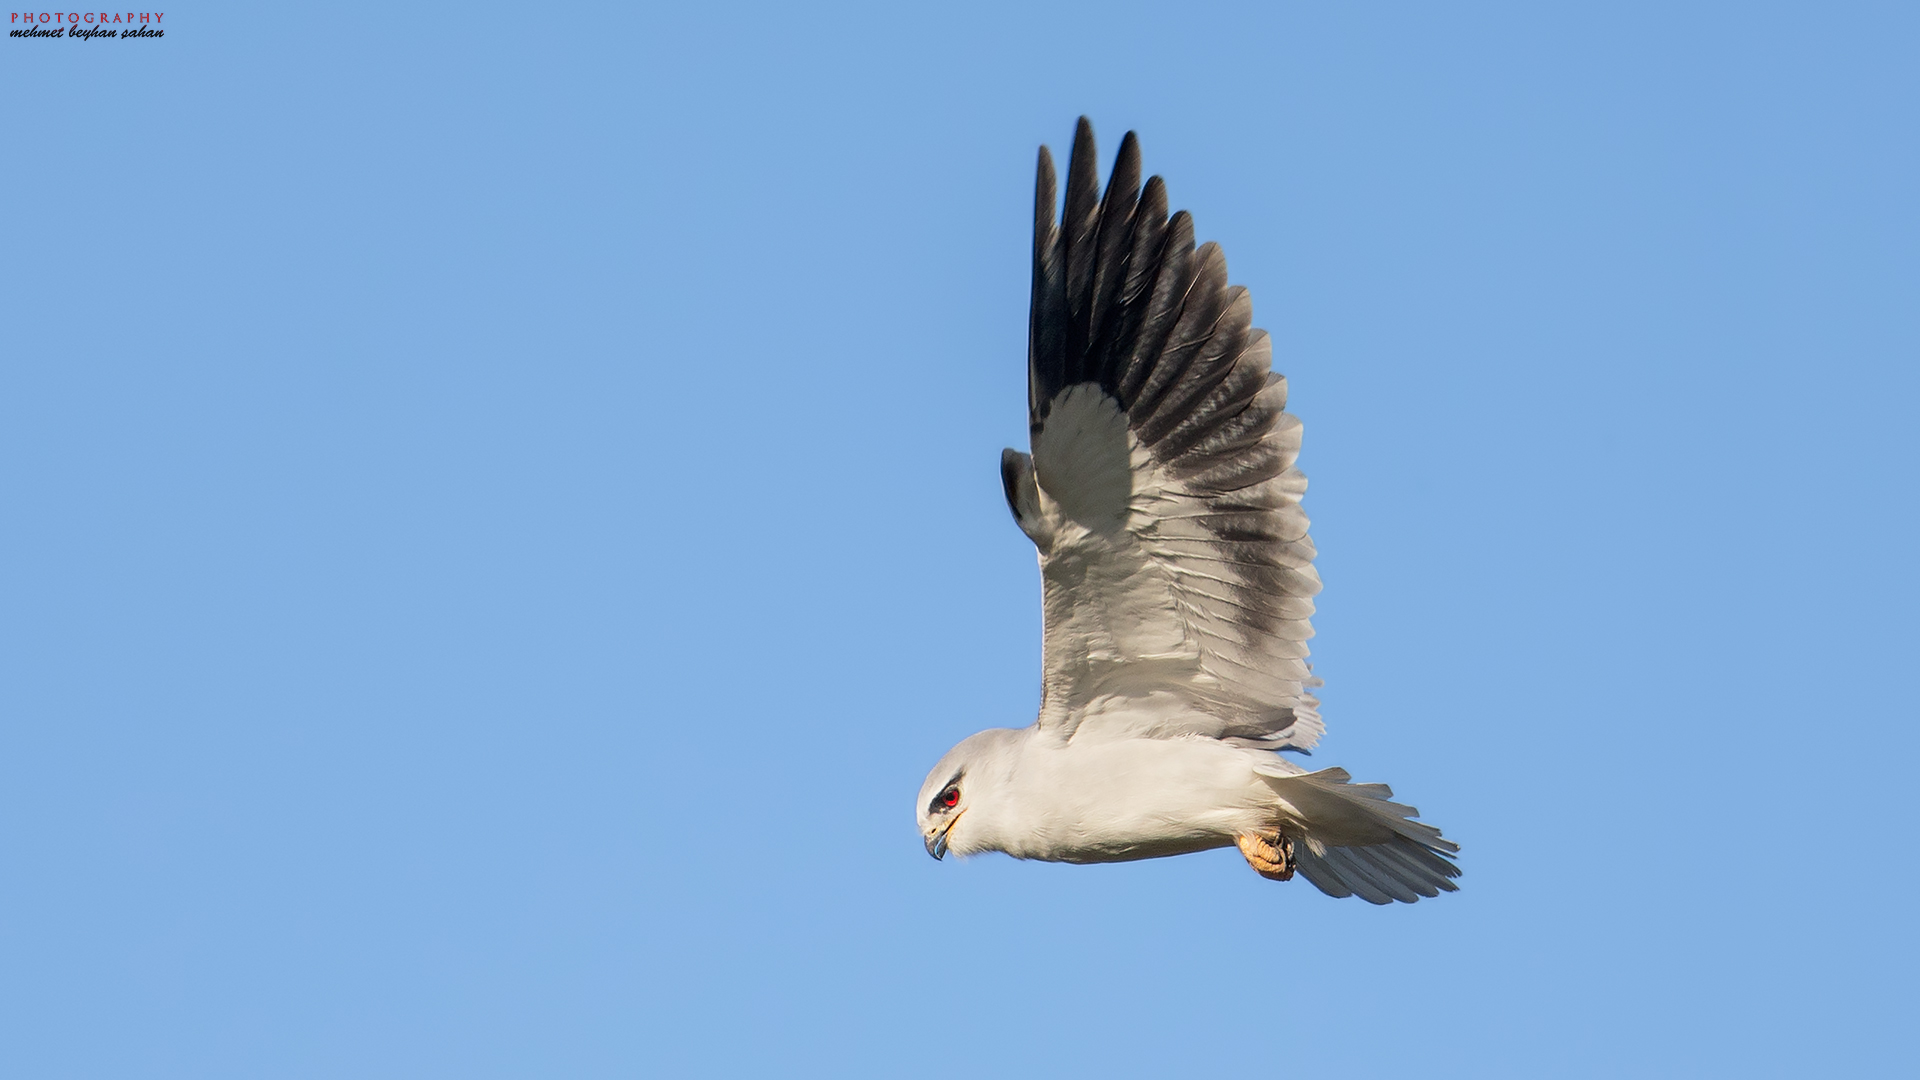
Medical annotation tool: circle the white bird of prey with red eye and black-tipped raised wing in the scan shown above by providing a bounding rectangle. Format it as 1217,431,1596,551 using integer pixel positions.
916,117,1459,903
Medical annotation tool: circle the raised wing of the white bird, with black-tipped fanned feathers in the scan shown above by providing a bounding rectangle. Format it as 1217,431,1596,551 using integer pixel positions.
1000,117,1323,749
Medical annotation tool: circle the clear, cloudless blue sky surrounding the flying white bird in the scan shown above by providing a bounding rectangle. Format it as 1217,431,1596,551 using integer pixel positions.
0,4,1920,1078
